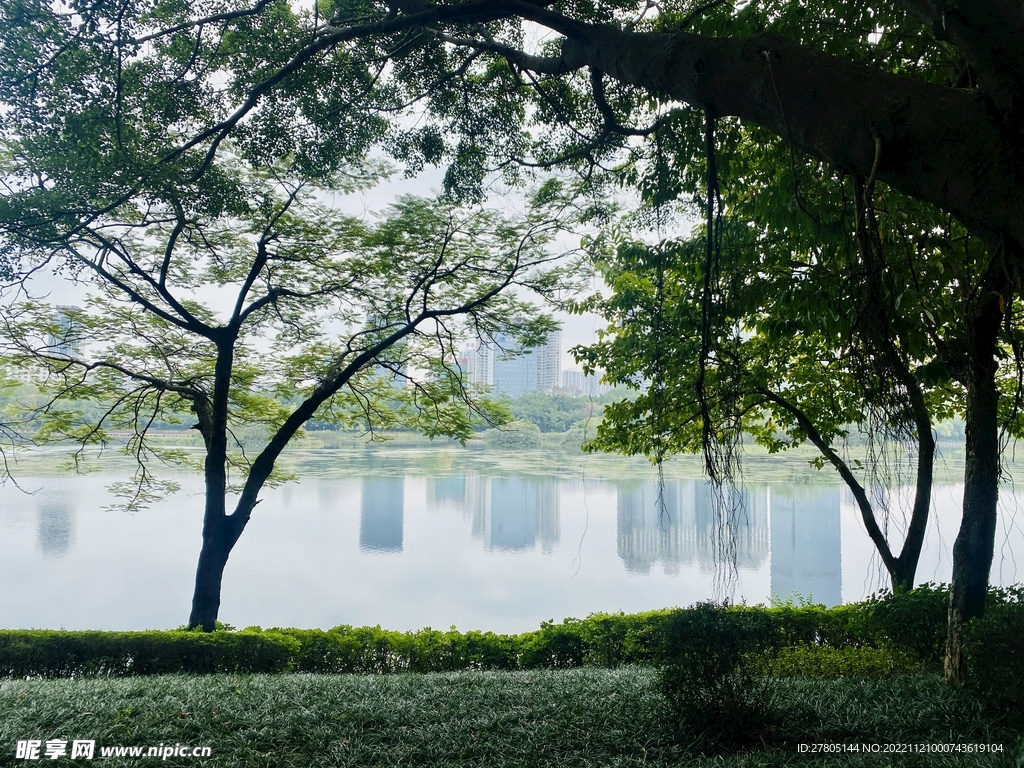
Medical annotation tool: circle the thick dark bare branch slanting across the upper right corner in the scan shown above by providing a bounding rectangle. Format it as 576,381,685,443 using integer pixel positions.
366,5,1024,252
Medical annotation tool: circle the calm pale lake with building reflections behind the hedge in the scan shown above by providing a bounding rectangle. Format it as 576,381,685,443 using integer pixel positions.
0,444,1024,632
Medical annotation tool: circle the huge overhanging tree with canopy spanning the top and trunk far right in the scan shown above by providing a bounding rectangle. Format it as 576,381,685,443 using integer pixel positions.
0,0,1024,675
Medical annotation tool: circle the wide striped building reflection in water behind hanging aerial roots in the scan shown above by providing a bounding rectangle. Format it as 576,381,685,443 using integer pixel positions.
616,480,768,573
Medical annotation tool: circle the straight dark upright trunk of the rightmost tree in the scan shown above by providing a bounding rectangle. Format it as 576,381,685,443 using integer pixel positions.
945,295,1006,680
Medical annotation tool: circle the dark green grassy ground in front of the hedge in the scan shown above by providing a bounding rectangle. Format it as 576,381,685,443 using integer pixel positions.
0,668,1024,768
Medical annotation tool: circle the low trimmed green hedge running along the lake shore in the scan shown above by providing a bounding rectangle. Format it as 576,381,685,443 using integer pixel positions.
0,585,1024,678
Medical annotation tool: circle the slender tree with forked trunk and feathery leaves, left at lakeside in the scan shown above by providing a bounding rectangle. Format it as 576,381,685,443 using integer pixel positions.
0,159,577,631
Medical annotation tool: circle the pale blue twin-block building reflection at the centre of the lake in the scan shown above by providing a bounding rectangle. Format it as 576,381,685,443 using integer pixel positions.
466,476,561,553
